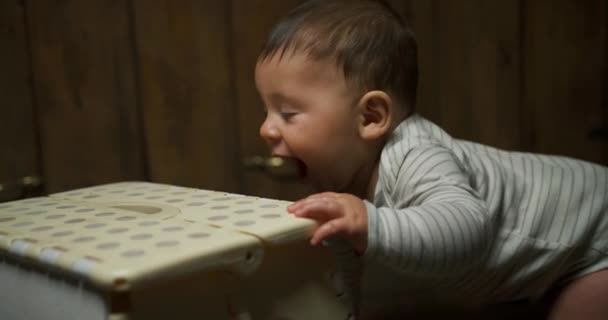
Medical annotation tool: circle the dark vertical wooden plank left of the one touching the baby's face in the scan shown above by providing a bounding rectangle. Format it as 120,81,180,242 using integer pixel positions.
133,0,240,192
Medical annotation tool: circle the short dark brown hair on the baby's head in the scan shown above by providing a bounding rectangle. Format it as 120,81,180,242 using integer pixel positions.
258,0,418,111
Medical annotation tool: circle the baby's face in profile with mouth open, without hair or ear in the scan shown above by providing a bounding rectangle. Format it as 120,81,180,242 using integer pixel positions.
255,53,364,191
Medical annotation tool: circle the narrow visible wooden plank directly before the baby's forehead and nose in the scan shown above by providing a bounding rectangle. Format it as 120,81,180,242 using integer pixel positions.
233,0,310,199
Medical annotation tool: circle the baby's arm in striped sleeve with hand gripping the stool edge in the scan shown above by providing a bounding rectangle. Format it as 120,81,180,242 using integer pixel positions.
289,146,493,275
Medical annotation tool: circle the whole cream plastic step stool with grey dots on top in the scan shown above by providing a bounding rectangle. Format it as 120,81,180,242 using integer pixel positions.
0,182,348,320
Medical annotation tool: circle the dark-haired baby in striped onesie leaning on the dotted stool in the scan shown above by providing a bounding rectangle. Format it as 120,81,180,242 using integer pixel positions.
255,0,608,319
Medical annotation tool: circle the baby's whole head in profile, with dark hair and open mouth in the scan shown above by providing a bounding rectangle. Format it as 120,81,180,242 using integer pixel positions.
256,0,418,193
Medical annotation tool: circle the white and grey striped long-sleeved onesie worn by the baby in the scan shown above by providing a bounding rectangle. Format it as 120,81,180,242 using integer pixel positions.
342,115,608,316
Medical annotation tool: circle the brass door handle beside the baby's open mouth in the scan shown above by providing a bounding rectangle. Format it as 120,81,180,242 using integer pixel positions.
243,156,303,180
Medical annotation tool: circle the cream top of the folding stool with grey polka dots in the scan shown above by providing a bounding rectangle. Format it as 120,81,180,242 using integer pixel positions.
0,182,320,287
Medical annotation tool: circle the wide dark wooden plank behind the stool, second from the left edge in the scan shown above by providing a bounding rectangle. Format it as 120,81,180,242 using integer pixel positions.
27,0,144,192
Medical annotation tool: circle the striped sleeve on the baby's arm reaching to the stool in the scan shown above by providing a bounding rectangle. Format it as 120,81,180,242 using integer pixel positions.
366,144,492,277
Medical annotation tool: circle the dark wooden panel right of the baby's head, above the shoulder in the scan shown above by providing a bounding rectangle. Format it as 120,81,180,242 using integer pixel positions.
406,0,524,149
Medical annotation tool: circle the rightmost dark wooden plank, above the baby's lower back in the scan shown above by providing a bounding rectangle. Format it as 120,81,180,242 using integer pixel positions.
524,0,608,163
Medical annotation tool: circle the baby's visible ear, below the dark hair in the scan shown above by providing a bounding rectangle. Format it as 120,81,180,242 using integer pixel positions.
358,90,395,140
